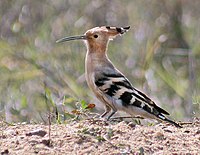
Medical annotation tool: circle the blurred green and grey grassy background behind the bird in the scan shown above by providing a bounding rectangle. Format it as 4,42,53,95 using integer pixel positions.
0,0,200,122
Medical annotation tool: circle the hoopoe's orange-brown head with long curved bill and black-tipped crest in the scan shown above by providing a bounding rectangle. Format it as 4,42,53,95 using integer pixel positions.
56,26,130,49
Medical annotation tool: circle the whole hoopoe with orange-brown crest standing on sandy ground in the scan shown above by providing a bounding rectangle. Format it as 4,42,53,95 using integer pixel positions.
56,26,182,128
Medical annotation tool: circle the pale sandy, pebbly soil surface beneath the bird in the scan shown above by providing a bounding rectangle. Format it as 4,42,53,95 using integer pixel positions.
0,119,200,155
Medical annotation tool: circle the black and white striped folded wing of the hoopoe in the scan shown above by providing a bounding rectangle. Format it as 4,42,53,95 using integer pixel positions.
95,73,169,118
